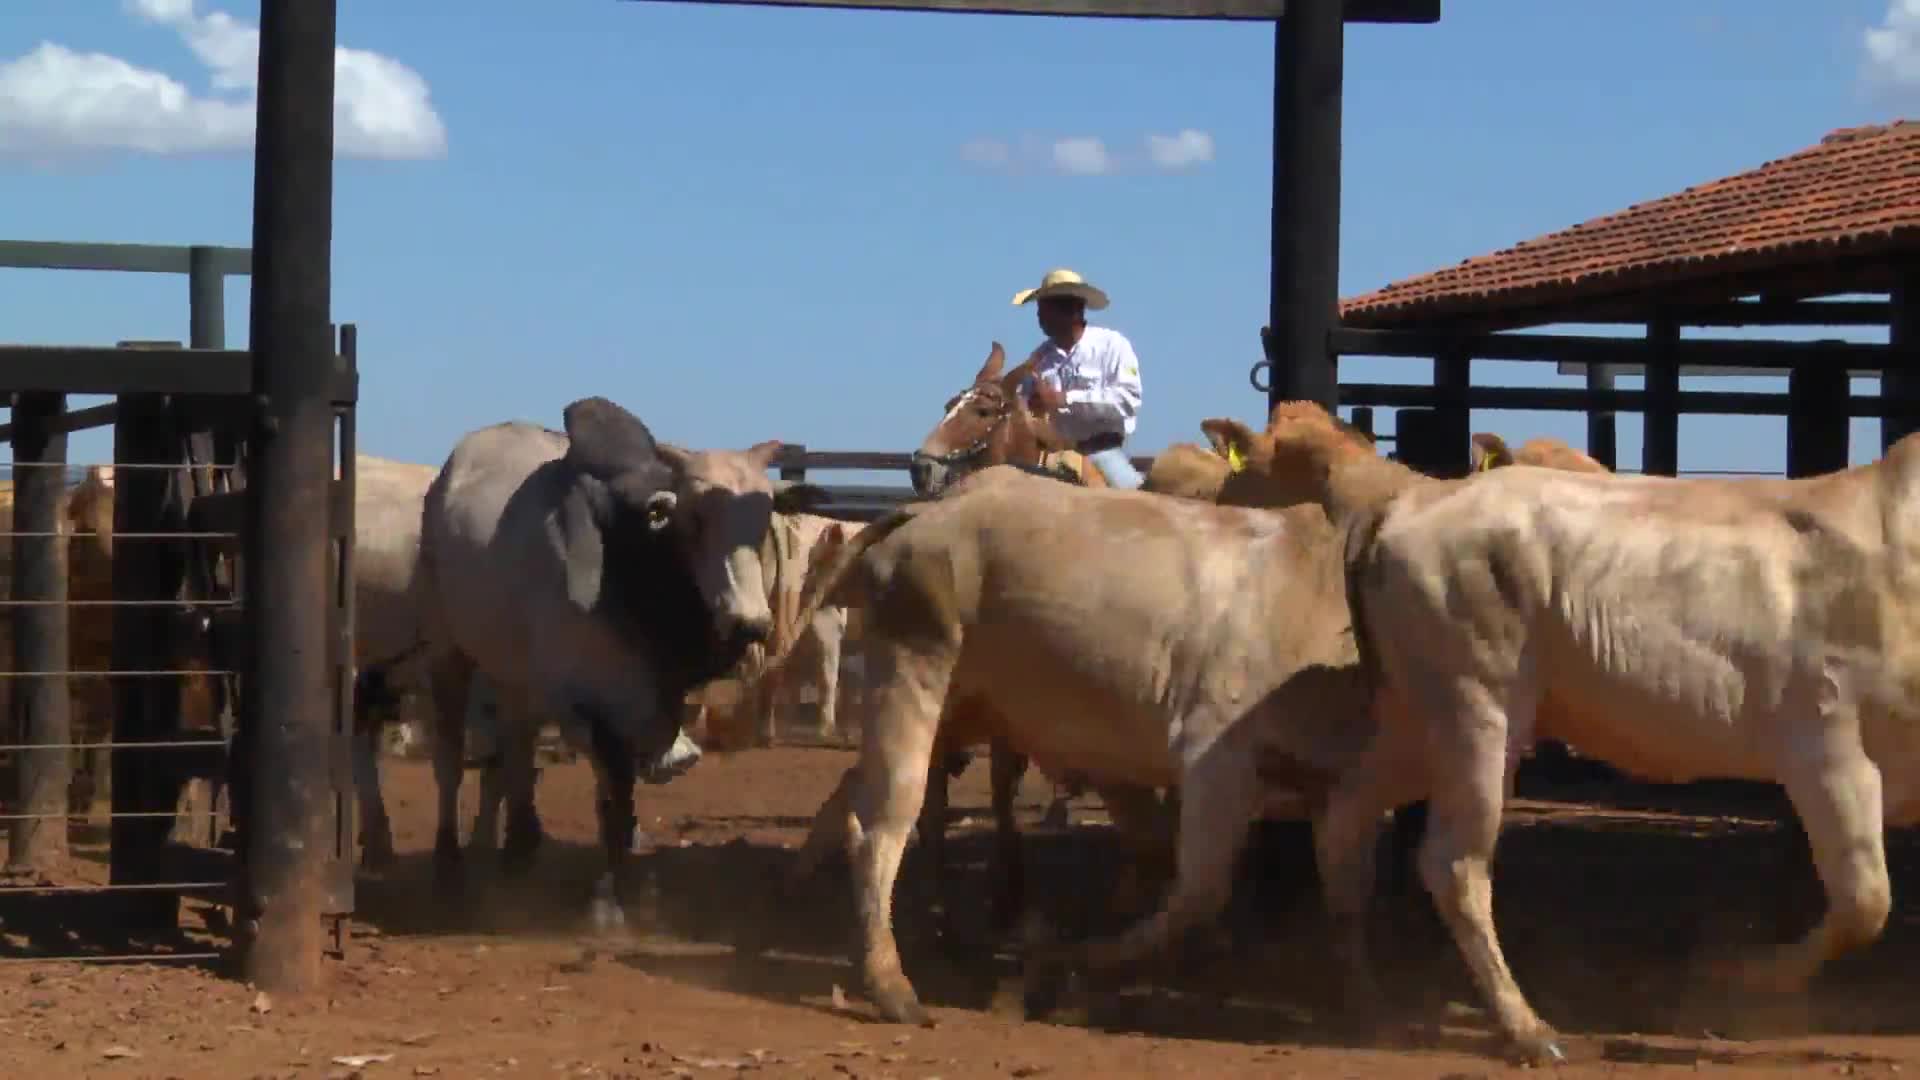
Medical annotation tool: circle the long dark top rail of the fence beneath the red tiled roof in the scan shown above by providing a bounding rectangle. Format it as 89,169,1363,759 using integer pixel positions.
1329,329,1895,368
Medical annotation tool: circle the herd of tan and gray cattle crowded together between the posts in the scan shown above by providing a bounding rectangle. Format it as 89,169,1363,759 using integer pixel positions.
7,346,1920,1061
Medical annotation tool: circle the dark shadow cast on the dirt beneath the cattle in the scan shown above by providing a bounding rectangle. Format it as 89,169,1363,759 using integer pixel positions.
345,809,1920,1065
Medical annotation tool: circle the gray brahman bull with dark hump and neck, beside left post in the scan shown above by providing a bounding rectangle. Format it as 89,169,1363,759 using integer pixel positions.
415,398,826,926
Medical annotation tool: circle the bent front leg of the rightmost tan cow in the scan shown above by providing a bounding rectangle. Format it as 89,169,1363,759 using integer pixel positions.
1734,687,1893,994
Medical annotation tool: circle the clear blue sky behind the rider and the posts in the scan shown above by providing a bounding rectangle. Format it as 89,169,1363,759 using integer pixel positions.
0,0,1920,480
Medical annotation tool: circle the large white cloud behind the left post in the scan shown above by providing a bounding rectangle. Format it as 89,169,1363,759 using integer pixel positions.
0,0,447,160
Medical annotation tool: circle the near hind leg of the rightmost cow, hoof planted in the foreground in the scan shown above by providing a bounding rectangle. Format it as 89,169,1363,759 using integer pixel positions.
1413,675,1565,1063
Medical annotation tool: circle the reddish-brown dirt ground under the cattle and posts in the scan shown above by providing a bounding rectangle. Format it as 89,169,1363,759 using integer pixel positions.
0,749,1920,1080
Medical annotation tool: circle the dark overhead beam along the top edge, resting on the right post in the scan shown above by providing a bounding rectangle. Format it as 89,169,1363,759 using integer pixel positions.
628,0,1440,23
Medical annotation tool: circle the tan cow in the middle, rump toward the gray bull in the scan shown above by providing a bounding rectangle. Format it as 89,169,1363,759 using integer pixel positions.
764,457,1371,1022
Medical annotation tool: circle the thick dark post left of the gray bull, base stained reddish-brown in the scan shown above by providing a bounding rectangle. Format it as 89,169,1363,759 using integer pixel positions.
242,0,336,994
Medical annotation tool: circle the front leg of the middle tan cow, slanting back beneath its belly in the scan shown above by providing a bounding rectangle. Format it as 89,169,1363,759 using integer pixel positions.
1027,724,1261,1015
